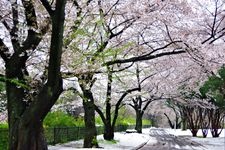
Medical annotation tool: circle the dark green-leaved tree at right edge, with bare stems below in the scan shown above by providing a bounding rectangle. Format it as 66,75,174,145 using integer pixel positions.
199,66,225,137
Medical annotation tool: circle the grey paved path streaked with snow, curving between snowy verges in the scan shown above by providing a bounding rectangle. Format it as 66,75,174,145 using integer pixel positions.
138,129,204,150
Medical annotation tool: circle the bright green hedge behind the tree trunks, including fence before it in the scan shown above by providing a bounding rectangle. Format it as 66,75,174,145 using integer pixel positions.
0,111,151,150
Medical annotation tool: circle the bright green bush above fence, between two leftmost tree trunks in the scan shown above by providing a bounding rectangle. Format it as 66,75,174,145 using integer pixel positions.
44,111,84,127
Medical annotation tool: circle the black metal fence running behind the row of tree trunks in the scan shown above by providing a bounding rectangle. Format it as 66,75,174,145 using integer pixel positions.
0,125,150,150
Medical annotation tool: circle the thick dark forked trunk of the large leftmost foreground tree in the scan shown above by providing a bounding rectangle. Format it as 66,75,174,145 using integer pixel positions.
0,0,66,150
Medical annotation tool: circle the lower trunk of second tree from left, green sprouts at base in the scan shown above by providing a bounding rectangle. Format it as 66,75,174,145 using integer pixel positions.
83,100,98,148
